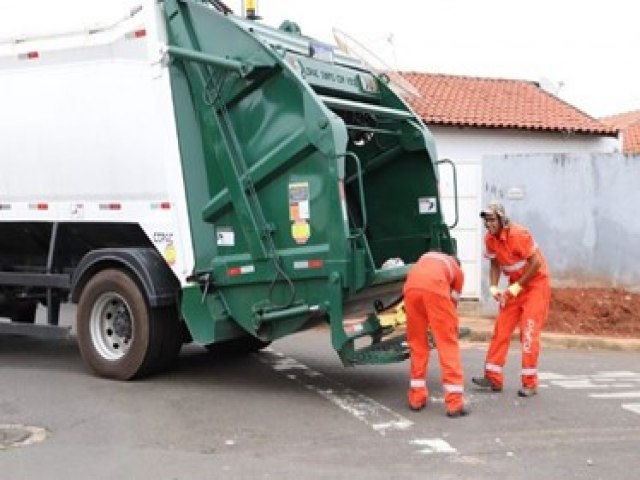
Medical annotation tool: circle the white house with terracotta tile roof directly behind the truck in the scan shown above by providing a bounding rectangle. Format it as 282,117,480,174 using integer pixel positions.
392,72,620,298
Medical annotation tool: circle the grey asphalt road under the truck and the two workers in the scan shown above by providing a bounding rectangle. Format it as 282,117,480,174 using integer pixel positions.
0,316,640,480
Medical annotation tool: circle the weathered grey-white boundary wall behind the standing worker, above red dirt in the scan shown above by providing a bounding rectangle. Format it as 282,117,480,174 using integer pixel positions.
482,153,640,312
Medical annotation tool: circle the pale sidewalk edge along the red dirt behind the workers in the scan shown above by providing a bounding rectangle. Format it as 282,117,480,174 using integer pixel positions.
460,316,640,351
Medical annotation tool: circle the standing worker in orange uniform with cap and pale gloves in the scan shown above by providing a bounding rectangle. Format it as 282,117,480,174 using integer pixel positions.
471,202,551,397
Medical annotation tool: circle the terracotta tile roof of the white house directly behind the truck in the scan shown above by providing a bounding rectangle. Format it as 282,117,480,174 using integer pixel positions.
400,72,617,136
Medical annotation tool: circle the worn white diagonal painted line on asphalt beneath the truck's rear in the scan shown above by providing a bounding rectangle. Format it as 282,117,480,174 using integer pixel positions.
257,348,458,454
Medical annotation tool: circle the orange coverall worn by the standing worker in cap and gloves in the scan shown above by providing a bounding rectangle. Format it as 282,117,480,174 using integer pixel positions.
485,223,551,389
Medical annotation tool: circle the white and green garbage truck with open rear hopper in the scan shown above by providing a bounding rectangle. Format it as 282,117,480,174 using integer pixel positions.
0,0,456,380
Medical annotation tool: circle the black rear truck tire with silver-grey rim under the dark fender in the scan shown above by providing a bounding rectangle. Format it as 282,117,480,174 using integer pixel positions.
76,269,176,380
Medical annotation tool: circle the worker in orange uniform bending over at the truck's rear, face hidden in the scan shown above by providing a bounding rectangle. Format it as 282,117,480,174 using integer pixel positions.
404,252,468,418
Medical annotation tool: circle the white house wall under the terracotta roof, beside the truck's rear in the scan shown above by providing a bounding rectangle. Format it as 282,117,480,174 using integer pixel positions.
429,126,620,299
